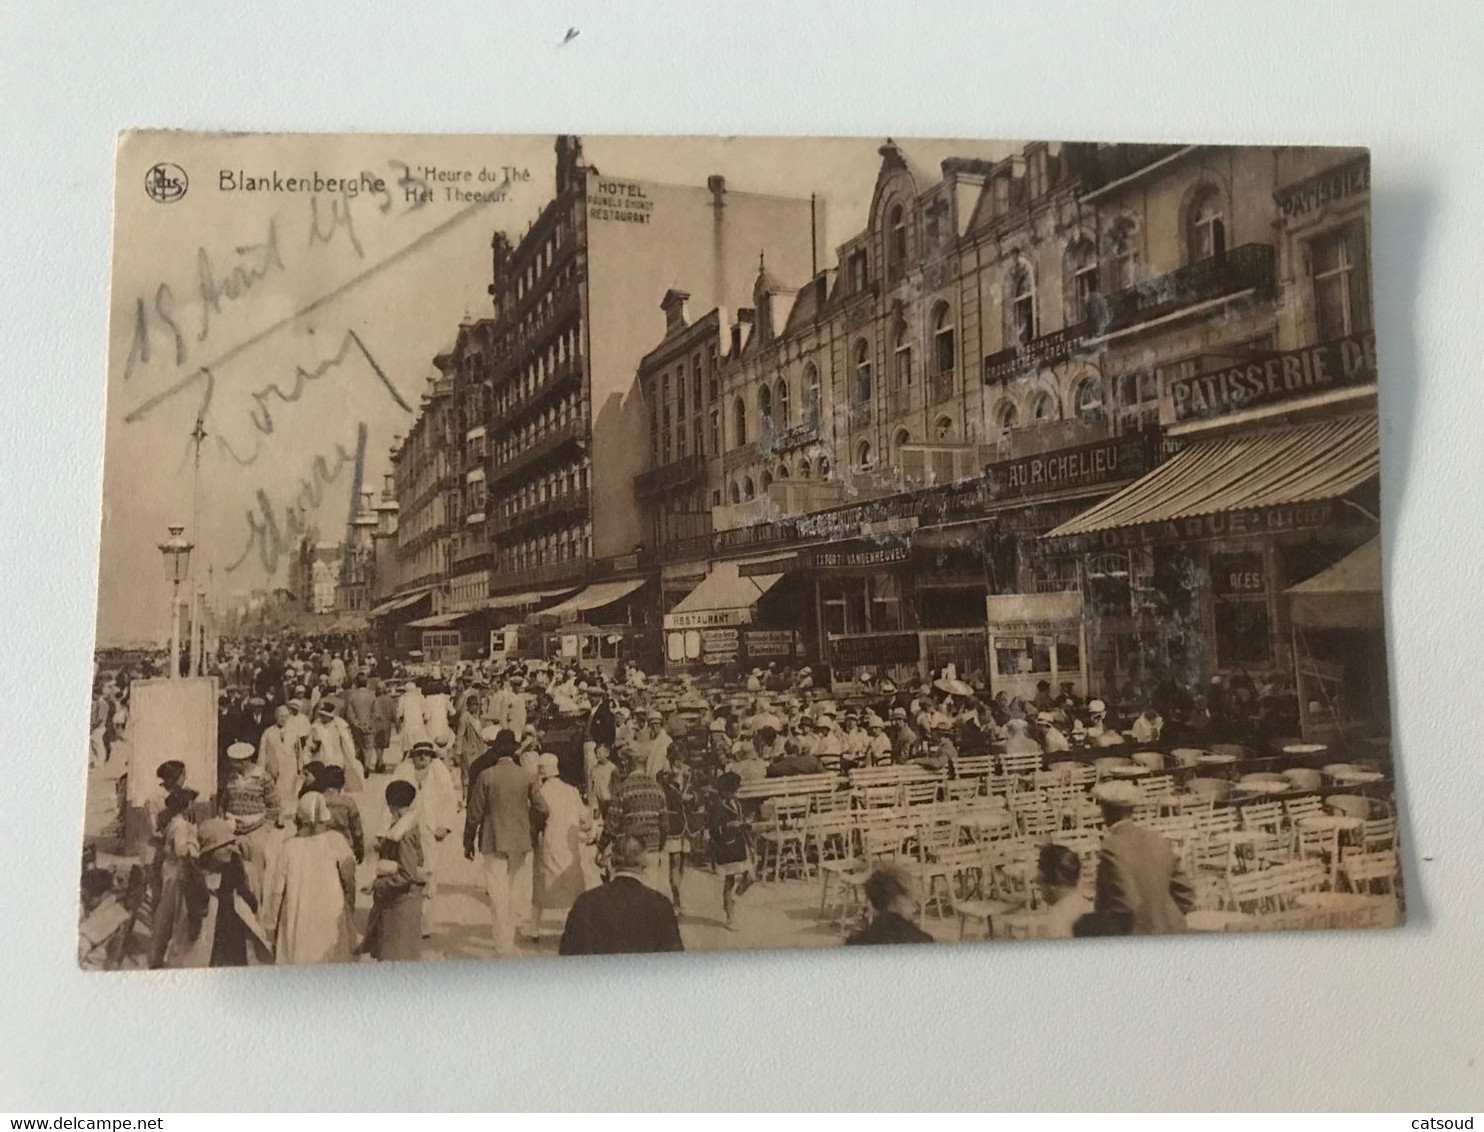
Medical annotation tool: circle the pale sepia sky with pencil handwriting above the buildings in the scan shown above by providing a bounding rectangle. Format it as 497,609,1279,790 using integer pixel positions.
98,134,1014,644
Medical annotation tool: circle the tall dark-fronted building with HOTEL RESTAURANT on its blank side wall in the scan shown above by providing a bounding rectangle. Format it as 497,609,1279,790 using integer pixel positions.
376,138,822,656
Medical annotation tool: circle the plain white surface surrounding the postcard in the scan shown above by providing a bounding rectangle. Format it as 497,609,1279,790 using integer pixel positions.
0,0,1484,1113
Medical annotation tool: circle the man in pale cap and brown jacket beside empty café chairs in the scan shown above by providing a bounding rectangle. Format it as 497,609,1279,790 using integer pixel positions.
1092,782,1196,935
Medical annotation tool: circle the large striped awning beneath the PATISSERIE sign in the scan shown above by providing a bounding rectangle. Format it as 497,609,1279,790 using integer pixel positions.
1046,417,1380,539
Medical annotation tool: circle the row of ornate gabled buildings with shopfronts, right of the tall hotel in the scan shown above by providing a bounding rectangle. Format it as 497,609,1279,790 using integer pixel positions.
637,142,1377,744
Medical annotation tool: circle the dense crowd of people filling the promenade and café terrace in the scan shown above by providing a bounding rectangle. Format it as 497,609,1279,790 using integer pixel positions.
85,638,1311,966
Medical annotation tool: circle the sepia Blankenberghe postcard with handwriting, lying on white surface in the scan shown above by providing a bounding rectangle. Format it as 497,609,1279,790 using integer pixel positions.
79,132,1402,969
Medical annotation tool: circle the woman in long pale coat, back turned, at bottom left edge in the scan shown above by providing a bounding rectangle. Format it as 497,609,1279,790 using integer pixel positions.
263,791,356,964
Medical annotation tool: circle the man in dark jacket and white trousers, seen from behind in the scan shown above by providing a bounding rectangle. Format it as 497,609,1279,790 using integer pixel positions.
464,745,548,958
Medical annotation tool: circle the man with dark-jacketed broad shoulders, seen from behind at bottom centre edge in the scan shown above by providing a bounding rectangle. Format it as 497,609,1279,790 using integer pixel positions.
559,835,686,955
